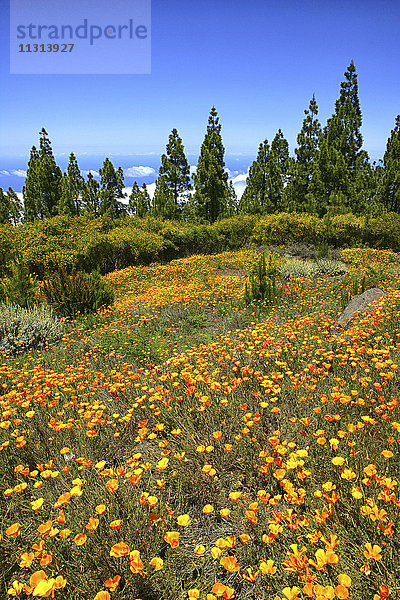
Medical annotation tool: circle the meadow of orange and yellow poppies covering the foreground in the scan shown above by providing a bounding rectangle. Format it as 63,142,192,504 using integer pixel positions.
0,248,400,600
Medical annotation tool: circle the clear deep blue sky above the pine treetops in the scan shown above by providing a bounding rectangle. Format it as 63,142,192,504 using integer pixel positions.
0,0,400,159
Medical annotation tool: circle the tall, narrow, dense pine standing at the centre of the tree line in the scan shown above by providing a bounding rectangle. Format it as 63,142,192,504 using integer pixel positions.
193,106,228,222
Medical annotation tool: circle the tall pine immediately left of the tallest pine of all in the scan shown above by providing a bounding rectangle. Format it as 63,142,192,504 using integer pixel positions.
284,94,322,212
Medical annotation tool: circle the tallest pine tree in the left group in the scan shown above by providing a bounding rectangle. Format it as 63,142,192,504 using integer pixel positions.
22,128,62,221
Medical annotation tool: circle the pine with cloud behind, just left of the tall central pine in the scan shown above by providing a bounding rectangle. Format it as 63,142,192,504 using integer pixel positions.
158,129,191,207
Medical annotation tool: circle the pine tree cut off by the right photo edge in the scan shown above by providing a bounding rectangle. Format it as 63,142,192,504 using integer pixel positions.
379,115,400,212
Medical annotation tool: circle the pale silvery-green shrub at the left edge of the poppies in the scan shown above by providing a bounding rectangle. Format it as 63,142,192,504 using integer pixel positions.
0,304,63,354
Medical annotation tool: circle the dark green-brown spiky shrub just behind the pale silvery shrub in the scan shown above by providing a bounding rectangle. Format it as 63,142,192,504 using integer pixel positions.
42,269,114,317
